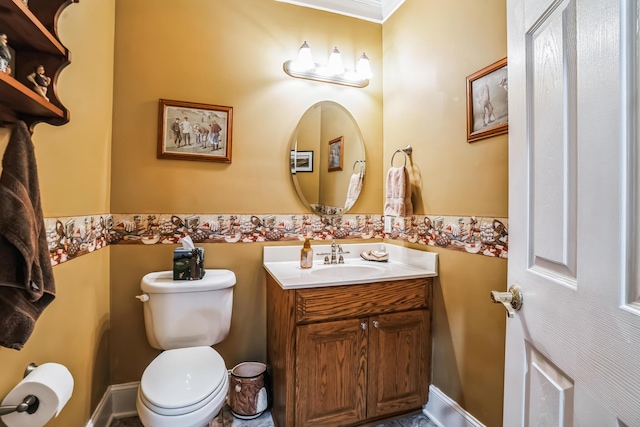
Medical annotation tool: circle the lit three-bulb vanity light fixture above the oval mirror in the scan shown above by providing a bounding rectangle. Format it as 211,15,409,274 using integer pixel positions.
283,41,373,87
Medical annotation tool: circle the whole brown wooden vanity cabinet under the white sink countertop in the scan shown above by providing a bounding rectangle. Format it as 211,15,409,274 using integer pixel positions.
267,274,432,427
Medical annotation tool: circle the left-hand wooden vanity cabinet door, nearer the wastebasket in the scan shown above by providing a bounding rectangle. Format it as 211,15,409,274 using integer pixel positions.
295,318,370,427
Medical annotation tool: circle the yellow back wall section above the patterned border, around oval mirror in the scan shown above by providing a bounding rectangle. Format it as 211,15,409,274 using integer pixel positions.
111,0,382,213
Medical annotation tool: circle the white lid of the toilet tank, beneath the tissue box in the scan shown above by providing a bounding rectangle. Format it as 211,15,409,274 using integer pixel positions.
140,269,236,294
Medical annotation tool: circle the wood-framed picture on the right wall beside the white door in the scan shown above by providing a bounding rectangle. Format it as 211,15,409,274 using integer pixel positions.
467,58,509,142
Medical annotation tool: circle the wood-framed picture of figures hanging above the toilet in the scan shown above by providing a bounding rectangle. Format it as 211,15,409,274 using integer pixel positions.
158,99,233,163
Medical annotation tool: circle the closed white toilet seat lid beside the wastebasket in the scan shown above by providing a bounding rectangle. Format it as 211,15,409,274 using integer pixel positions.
139,346,228,416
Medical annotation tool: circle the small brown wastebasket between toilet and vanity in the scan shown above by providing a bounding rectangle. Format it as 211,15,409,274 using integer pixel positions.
229,362,269,420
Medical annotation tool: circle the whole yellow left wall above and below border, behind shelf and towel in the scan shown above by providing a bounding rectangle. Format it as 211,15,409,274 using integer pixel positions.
0,0,115,427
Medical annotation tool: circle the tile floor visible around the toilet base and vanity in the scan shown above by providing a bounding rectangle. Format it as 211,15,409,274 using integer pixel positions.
110,407,436,427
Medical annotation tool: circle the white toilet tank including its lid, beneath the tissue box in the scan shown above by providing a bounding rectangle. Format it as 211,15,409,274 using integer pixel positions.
138,269,236,350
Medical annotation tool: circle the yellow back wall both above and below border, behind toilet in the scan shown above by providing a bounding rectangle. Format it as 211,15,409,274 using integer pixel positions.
111,0,382,383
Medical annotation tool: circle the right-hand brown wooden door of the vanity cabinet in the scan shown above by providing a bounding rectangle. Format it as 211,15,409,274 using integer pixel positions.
367,310,431,418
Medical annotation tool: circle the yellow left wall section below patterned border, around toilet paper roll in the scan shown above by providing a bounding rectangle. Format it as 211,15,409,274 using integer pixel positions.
0,251,110,427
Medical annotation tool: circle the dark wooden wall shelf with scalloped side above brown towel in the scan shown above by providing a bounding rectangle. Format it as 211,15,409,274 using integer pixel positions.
0,0,78,130
